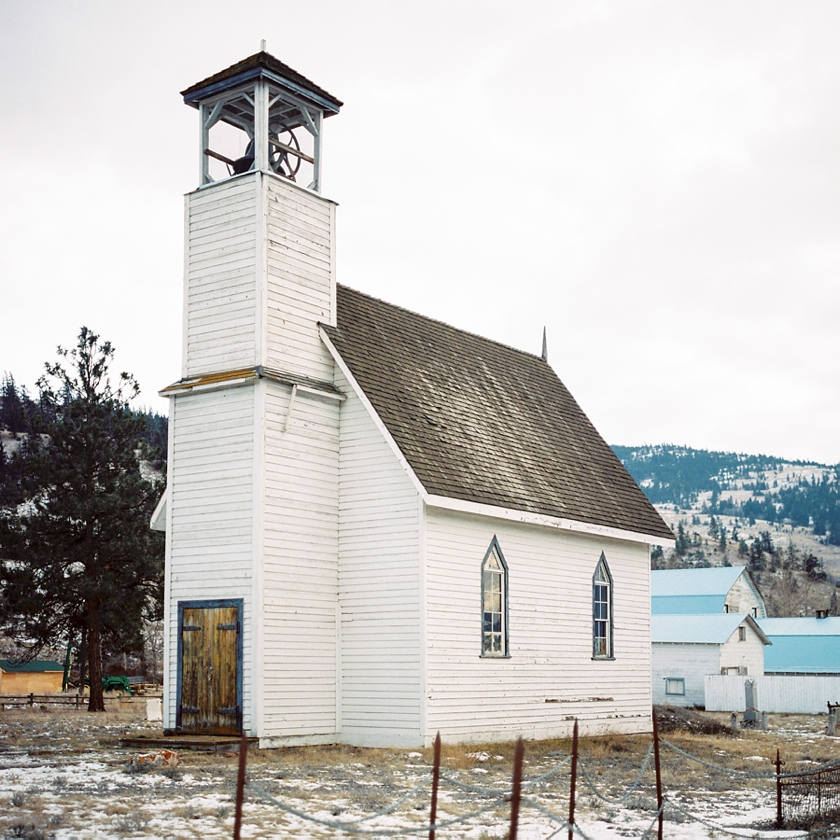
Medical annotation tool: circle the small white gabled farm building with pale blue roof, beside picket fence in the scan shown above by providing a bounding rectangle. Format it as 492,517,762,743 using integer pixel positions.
650,613,770,706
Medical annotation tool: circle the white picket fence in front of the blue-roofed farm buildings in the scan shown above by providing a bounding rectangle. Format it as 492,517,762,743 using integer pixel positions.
706,674,840,715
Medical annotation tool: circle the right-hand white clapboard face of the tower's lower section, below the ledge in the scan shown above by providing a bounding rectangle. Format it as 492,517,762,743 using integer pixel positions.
260,380,339,746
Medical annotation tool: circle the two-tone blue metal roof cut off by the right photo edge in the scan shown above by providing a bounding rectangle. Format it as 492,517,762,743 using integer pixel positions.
758,617,840,674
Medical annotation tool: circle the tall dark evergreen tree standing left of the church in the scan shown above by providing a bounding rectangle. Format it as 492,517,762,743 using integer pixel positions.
0,327,163,711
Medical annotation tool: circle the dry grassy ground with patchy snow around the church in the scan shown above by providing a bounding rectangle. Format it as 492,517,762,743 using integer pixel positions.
0,707,840,840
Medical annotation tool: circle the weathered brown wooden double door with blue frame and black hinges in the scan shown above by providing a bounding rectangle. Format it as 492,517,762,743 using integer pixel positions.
177,601,242,735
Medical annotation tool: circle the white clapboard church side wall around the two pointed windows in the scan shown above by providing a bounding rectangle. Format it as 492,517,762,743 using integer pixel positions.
426,509,651,741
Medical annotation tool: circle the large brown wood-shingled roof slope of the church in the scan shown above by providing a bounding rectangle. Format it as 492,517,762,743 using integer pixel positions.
324,286,673,540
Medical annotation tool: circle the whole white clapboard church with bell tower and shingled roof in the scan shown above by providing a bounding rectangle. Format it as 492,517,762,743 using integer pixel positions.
152,51,672,747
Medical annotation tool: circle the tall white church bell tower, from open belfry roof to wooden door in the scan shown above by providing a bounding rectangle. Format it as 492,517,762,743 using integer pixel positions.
159,50,343,745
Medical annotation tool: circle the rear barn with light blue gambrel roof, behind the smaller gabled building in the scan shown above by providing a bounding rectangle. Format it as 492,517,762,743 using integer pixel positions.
650,566,767,618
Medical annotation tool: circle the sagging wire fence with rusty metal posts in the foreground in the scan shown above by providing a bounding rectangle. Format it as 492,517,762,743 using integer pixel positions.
220,711,840,840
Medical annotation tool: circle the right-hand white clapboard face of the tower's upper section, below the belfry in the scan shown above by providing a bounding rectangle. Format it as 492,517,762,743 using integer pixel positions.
264,176,335,380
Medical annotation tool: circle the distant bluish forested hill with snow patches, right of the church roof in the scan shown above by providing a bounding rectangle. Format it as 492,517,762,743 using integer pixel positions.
613,445,840,545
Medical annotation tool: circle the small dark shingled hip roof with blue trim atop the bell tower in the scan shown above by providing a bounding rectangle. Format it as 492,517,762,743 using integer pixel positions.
181,50,344,117
